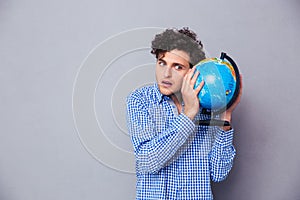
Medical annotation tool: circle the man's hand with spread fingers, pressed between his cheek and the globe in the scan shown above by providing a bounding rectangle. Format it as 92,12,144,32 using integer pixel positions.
181,67,204,120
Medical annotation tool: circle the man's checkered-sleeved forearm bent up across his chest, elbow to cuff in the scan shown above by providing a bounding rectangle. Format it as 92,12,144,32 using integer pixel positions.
132,114,195,173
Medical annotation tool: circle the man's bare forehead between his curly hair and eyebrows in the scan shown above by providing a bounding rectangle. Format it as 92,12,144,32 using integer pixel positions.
158,49,190,66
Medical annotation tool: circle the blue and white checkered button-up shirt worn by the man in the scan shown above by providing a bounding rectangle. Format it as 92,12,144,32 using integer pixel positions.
127,84,235,200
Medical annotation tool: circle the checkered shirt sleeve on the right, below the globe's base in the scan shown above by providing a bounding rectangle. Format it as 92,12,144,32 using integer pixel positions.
209,128,236,182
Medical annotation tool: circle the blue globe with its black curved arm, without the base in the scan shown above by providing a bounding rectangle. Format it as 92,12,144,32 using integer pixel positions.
194,53,240,113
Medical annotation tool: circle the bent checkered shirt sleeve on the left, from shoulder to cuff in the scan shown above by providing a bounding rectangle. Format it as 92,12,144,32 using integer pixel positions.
127,92,195,173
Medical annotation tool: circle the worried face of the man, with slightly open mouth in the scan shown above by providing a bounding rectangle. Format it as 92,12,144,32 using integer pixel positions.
155,49,190,95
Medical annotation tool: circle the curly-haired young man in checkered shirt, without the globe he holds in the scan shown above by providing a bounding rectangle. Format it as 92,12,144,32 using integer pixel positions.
127,28,241,200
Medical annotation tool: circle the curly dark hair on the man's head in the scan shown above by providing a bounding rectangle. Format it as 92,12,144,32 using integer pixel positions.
151,27,205,67
